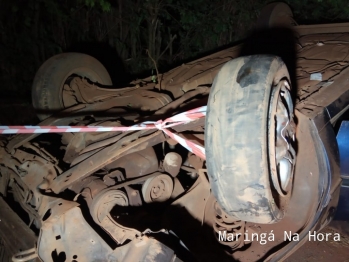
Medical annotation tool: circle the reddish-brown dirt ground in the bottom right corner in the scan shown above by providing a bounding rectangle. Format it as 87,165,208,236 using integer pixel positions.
285,227,349,262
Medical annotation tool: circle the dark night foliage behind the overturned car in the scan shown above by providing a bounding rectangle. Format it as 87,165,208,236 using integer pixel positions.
0,0,349,95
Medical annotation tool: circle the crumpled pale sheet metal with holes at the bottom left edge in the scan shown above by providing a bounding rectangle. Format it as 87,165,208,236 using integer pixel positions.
37,201,176,262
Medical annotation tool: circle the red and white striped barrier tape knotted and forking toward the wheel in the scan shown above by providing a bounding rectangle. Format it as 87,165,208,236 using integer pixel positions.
0,106,207,159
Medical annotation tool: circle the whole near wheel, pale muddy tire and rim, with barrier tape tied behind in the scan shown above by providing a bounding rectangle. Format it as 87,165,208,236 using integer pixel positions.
205,55,295,223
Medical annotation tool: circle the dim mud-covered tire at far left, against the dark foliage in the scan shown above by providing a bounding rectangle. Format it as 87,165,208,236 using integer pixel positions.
32,53,112,120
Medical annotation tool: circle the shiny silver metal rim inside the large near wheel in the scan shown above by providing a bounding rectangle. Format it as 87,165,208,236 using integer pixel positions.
269,80,296,196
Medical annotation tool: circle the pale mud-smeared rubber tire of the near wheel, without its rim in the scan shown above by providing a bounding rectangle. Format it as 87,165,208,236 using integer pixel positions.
205,55,293,224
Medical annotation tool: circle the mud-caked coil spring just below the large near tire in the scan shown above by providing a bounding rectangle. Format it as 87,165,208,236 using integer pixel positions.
213,202,246,250
